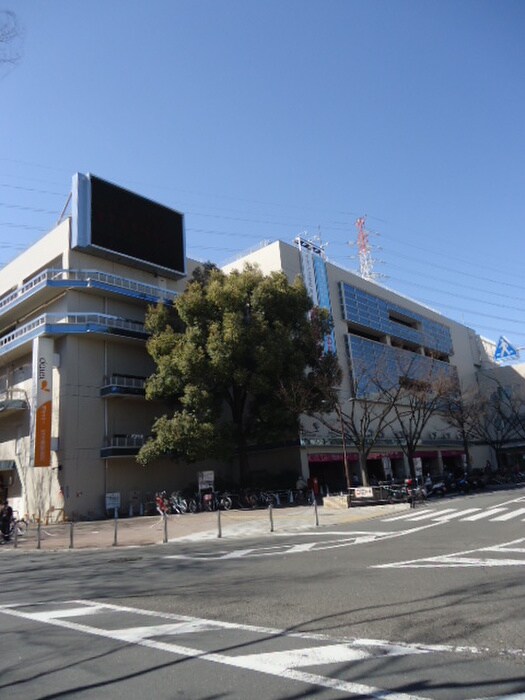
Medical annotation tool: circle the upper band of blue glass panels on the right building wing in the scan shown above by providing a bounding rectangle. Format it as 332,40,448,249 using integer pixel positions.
339,282,453,355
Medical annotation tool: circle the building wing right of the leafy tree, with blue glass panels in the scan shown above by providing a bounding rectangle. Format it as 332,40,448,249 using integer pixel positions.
225,238,494,490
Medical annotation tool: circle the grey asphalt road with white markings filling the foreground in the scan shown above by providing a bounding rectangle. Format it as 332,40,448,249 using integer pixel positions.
0,490,525,700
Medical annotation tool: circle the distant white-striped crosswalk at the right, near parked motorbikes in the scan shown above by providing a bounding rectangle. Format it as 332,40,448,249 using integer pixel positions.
381,504,525,523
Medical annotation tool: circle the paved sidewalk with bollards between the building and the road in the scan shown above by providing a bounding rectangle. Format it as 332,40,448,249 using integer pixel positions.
0,503,409,553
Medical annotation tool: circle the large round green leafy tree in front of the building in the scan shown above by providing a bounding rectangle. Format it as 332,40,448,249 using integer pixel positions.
138,266,340,483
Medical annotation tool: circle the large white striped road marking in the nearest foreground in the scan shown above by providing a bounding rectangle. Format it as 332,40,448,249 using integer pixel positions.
0,600,525,700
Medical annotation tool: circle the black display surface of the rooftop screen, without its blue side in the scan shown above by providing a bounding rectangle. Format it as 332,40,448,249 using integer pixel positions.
89,175,185,274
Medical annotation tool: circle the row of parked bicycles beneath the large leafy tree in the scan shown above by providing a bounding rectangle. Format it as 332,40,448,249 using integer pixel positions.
155,489,313,515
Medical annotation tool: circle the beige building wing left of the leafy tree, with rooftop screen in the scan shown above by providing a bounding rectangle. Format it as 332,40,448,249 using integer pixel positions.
0,175,199,520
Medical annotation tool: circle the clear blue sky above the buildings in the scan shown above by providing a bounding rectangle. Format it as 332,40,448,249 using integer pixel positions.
0,0,525,350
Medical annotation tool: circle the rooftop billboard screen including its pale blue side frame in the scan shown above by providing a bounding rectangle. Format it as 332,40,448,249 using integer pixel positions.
71,173,186,276
